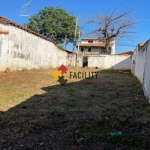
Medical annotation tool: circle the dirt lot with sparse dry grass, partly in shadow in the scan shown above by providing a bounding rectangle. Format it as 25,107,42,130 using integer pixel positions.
0,67,150,150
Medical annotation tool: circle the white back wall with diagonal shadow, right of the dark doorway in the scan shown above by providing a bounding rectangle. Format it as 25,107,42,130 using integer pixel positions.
78,55,131,70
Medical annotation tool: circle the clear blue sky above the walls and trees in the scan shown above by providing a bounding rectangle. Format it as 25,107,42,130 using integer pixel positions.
0,0,150,53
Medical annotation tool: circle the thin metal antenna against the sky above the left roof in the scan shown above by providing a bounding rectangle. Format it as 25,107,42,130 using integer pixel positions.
19,0,33,27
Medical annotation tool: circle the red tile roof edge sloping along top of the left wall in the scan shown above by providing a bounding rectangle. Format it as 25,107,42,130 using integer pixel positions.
0,16,56,44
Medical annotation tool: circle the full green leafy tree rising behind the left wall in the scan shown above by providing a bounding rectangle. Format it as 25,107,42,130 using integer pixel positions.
27,7,79,44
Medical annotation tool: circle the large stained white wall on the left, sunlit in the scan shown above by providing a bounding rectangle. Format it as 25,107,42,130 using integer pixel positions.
0,23,72,71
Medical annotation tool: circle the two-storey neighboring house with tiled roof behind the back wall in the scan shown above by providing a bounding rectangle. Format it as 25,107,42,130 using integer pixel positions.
78,38,115,55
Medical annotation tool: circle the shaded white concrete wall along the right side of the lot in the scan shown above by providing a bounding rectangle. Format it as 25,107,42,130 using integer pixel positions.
131,40,150,101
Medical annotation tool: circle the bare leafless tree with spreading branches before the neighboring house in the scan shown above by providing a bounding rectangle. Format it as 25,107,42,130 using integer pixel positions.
87,9,135,54
